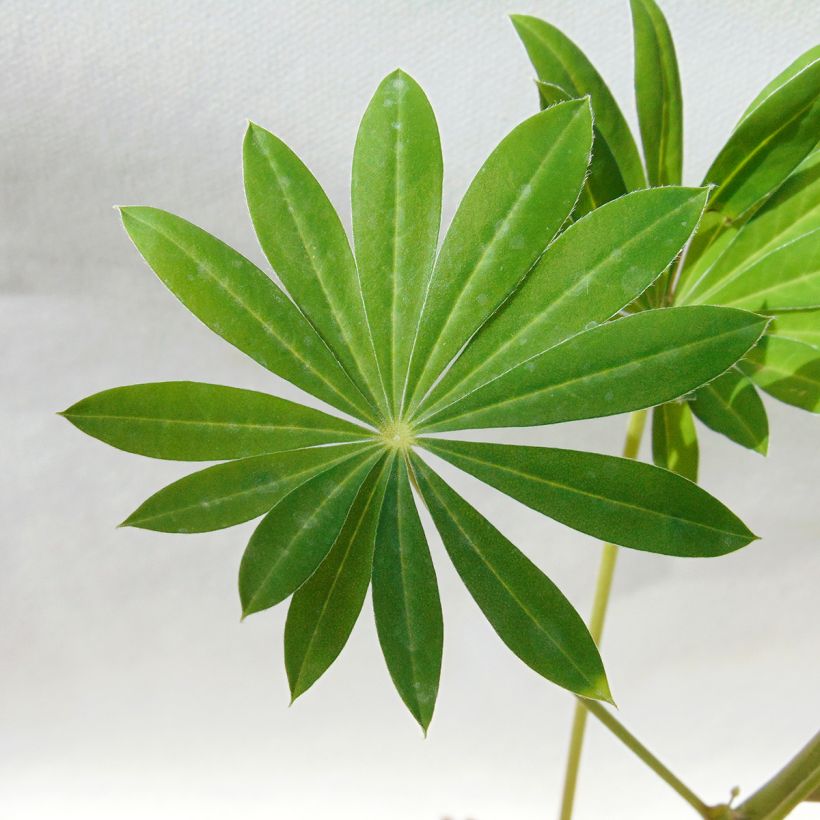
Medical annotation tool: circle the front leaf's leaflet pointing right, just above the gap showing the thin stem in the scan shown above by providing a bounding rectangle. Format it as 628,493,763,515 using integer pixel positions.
419,305,767,432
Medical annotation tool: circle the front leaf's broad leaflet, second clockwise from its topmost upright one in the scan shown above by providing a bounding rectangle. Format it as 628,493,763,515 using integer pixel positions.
420,187,707,415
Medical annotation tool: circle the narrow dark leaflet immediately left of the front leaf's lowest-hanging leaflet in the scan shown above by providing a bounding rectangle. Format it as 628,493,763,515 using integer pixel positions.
285,454,395,700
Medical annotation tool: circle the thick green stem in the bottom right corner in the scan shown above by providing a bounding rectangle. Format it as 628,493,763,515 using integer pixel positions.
737,732,820,820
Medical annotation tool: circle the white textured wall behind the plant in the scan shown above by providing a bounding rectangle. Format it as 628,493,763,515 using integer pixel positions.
0,0,820,820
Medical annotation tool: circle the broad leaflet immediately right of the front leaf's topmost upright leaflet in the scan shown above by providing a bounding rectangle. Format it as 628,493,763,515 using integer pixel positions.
406,100,592,411
